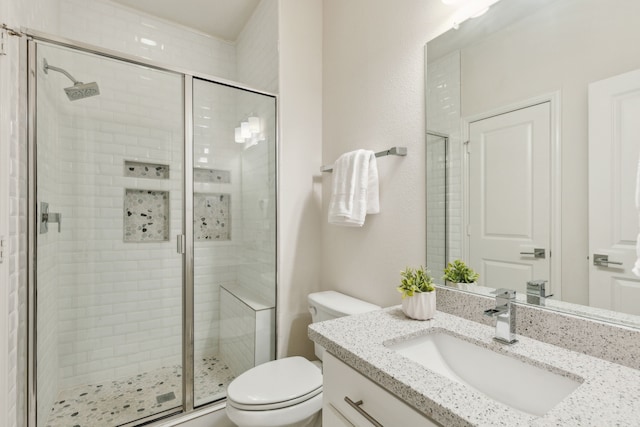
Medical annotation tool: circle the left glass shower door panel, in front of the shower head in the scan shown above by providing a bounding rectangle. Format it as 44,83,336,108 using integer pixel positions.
35,44,184,427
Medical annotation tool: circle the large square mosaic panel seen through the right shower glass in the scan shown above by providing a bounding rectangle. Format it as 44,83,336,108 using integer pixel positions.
193,193,231,240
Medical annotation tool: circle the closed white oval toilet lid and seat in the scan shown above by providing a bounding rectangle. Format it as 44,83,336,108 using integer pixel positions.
227,356,322,409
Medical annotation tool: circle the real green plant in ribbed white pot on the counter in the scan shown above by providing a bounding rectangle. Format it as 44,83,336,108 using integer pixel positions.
398,267,436,320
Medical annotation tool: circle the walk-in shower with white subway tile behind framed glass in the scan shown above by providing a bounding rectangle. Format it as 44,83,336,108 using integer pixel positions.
25,34,276,427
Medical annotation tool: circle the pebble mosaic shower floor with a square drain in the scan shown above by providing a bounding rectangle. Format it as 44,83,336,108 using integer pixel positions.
46,357,234,427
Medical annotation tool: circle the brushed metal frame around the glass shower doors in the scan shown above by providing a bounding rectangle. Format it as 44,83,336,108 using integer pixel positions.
21,29,280,427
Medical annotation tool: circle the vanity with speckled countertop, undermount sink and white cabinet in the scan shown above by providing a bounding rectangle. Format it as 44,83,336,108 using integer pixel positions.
309,307,640,427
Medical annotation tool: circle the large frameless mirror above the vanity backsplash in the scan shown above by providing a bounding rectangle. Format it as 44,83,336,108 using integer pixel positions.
425,0,640,327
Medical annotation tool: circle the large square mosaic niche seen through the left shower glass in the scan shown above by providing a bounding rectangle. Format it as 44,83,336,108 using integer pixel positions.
124,189,169,242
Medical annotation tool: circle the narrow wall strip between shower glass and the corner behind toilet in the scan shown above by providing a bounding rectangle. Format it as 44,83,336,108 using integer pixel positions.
277,0,323,357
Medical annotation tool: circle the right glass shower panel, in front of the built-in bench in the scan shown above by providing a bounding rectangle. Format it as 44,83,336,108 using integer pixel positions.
193,79,276,406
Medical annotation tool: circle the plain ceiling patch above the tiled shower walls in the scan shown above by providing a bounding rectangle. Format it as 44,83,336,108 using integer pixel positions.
113,0,260,41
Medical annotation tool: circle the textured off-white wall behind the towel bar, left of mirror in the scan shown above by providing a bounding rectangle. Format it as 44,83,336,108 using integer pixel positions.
321,0,452,306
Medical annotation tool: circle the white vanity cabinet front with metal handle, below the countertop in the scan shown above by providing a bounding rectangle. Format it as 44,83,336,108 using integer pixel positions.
322,352,439,427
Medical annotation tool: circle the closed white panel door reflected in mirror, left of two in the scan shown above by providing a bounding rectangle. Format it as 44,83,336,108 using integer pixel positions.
467,102,553,298
